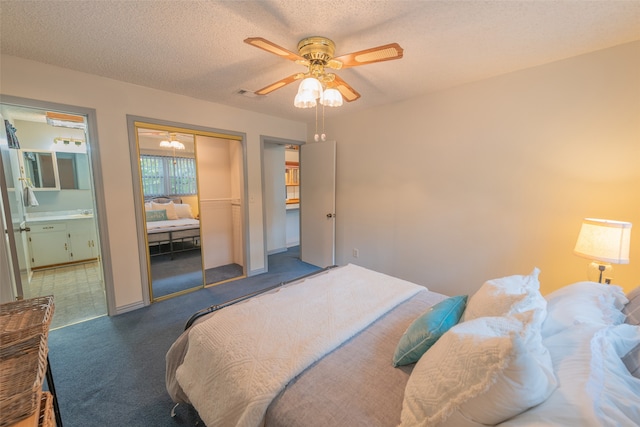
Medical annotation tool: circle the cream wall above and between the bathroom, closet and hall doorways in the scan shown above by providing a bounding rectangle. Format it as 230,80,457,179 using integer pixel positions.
0,55,307,307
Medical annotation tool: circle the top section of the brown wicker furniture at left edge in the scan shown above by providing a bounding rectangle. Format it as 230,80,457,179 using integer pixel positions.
0,296,54,347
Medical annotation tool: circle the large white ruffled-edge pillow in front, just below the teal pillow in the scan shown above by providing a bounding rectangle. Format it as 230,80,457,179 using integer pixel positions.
401,311,557,427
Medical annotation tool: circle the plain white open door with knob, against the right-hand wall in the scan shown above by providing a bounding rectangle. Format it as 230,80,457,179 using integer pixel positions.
300,141,336,267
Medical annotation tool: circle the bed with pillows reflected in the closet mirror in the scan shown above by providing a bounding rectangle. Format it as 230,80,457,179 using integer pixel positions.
144,197,200,259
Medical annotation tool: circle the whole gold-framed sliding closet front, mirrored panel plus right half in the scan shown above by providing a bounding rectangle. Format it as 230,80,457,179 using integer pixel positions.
134,121,245,301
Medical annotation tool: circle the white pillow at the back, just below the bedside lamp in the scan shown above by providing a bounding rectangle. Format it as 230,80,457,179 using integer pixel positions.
542,282,628,337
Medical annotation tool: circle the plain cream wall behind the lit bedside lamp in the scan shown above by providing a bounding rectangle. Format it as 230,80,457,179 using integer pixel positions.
322,42,640,295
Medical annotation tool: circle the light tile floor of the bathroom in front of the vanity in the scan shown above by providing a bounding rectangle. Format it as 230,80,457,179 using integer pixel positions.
23,261,107,329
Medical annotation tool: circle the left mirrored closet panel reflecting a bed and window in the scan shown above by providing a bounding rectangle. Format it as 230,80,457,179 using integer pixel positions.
136,127,204,301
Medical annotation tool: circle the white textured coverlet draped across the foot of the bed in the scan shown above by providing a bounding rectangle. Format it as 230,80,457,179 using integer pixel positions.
176,265,425,427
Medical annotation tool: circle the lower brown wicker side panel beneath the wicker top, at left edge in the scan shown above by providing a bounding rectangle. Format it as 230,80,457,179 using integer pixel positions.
0,334,47,427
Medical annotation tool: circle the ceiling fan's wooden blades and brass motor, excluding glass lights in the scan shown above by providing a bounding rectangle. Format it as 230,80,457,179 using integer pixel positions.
244,36,404,104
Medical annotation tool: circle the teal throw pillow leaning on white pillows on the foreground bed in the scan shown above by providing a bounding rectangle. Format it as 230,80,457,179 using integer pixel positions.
393,295,467,367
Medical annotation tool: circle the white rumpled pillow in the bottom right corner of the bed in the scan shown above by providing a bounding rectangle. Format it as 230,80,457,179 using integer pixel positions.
500,323,640,427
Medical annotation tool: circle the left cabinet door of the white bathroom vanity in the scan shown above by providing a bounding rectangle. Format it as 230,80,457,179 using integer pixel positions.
29,222,69,267
